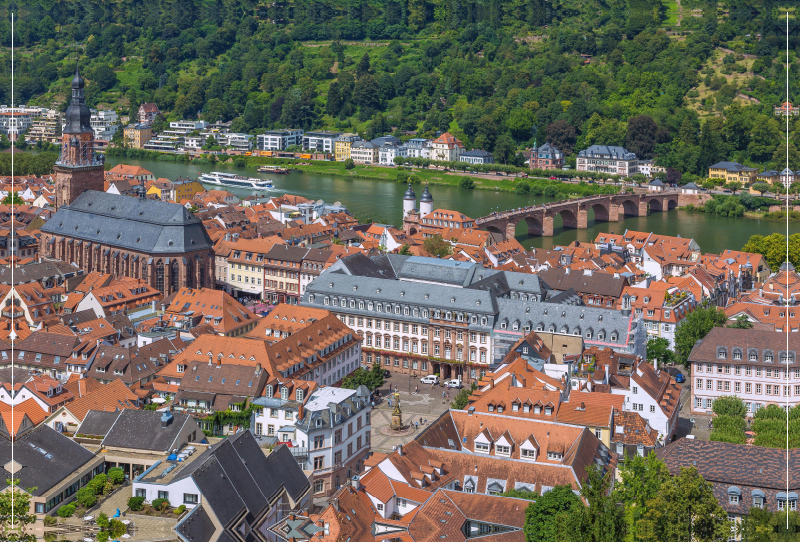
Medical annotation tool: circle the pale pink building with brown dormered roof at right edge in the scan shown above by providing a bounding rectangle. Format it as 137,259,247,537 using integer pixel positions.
689,327,800,416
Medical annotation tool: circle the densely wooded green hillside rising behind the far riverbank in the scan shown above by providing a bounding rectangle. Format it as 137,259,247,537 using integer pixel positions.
0,0,800,179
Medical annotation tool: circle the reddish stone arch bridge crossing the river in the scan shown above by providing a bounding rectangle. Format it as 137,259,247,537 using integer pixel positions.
475,192,682,239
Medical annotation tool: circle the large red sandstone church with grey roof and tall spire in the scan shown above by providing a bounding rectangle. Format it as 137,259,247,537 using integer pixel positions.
39,65,215,296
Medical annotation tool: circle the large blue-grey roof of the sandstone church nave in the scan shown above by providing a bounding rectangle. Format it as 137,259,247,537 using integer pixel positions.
41,190,214,254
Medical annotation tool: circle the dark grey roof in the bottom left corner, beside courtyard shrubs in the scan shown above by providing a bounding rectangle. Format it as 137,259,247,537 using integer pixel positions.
0,424,95,496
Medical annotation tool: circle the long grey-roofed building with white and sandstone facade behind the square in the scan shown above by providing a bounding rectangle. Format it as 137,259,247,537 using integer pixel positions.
300,254,645,382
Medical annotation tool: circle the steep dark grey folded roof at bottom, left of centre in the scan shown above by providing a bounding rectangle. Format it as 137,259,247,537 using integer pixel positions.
176,436,310,542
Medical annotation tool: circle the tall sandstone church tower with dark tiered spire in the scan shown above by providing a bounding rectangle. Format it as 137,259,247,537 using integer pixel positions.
54,66,105,207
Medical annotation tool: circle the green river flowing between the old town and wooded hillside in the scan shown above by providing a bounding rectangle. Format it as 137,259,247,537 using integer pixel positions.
107,157,800,252
